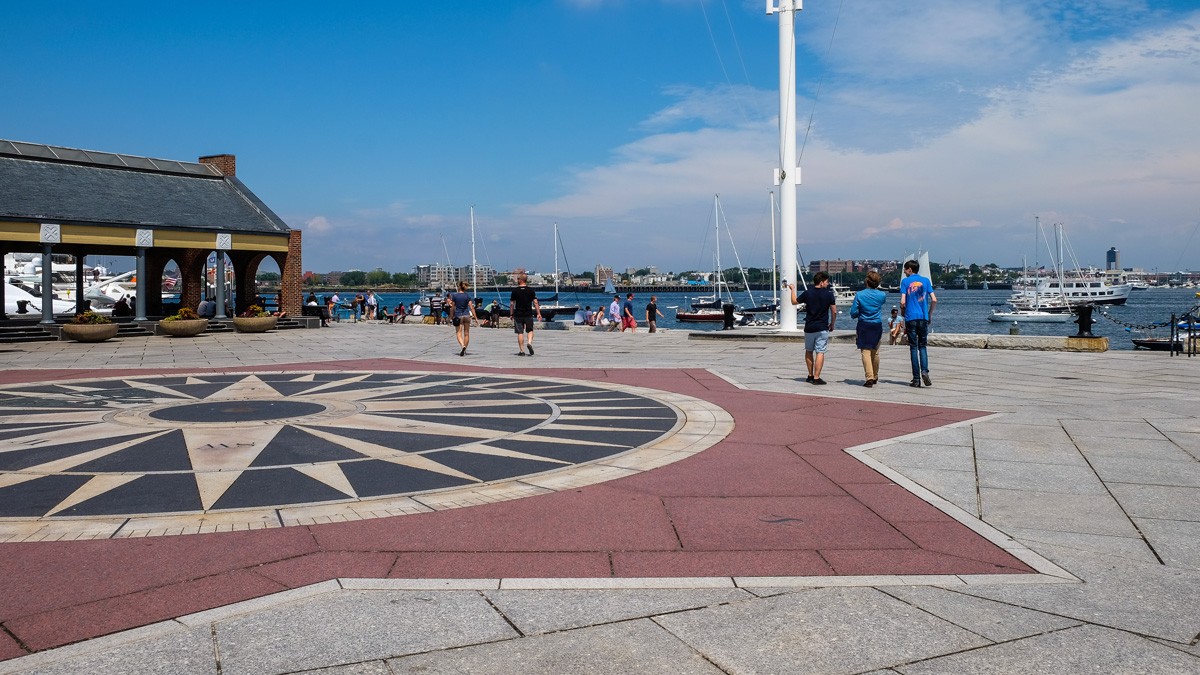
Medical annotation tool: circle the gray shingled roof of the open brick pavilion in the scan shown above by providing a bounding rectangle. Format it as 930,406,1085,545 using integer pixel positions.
0,142,290,233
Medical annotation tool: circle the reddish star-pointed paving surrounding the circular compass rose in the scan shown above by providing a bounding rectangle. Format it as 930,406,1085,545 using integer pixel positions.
0,359,1031,659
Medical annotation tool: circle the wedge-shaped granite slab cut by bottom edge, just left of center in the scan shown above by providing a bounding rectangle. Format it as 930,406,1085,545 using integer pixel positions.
388,619,721,675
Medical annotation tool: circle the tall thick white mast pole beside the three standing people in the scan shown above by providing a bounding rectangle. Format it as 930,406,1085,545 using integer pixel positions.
767,0,804,333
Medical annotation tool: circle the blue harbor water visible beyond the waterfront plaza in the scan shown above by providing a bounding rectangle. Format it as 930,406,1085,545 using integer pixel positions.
300,288,1200,350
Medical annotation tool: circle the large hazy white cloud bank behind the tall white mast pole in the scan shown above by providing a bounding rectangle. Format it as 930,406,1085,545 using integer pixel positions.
516,9,1200,267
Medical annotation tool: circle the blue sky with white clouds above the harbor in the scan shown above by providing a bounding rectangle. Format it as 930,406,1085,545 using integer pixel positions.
0,0,1200,273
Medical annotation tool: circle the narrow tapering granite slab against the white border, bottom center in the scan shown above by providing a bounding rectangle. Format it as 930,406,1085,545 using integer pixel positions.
484,589,752,635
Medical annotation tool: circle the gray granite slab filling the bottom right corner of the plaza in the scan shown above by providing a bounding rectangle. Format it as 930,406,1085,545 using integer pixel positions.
896,626,1200,675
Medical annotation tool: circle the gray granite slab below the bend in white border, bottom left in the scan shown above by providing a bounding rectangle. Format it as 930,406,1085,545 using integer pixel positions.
216,591,517,675
